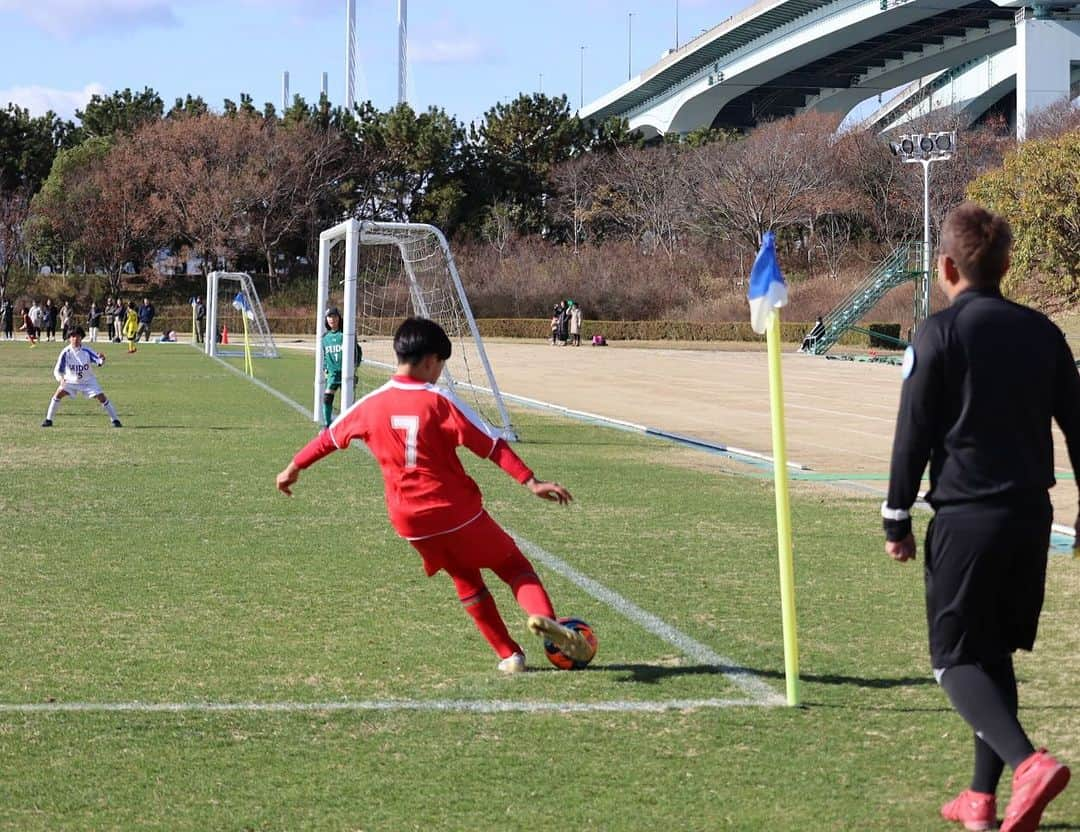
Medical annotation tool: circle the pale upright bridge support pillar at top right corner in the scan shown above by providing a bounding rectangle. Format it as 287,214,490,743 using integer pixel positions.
1016,9,1080,142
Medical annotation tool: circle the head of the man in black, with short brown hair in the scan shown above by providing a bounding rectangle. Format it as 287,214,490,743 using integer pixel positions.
940,202,1012,286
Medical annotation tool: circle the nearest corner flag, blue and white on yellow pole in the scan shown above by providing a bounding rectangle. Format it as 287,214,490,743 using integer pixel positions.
746,231,799,706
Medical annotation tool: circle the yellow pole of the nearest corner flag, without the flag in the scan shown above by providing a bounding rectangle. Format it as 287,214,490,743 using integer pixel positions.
766,309,799,707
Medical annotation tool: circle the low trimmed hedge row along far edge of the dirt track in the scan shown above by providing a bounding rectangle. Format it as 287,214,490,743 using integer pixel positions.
154,310,900,349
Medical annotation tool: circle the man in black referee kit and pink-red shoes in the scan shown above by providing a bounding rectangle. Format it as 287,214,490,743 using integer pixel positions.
881,202,1080,832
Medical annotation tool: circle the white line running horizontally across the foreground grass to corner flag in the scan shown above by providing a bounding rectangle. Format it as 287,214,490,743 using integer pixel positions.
0,699,762,714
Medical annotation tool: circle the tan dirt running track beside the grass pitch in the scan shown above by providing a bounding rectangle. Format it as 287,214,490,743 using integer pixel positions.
300,332,1078,526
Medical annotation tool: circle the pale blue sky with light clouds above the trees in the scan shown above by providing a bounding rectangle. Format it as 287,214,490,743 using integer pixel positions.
0,0,750,124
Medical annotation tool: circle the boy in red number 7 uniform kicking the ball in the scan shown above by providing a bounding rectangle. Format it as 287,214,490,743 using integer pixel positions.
276,318,591,673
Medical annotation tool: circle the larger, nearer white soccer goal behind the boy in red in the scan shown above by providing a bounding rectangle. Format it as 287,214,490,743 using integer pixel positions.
311,219,516,439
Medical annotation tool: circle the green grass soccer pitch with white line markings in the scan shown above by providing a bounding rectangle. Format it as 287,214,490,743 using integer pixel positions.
0,344,1080,831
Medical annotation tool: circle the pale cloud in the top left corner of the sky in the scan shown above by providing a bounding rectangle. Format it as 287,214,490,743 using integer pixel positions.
0,0,179,39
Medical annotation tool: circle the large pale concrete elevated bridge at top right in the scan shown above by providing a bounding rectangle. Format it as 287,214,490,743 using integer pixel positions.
580,0,1080,138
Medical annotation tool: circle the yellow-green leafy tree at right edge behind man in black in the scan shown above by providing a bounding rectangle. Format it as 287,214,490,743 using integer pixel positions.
968,131,1080,300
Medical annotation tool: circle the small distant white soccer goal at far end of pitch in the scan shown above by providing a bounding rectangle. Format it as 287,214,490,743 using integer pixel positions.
203,271,278,359
